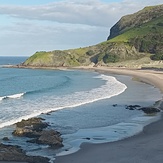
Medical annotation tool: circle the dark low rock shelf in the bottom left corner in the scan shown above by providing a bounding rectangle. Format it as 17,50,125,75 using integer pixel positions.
0,144,49,163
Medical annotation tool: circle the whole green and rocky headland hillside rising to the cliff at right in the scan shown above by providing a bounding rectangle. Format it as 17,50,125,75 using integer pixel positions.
23,5,163,67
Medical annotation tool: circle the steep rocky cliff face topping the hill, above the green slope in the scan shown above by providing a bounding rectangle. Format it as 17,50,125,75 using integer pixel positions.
108,5,163,40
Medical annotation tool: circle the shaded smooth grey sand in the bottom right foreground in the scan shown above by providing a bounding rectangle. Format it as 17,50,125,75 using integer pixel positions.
55,113,163,163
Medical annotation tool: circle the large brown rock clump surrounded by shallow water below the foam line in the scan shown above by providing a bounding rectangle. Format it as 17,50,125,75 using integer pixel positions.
13,118,63,148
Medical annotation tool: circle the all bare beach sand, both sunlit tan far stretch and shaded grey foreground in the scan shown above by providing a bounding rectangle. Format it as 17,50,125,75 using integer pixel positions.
55,67,163,163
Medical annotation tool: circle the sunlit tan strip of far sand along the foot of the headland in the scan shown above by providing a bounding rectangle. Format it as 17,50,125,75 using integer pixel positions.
9,65,163,93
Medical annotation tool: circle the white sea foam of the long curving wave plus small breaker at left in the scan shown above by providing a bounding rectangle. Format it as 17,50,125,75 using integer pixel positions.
0,75,127,128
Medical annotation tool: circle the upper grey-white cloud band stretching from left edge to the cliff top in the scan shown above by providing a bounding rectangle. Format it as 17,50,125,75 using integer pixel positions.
0,0,161,27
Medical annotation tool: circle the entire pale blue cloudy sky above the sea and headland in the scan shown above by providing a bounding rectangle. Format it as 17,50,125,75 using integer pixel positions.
0,0,162,56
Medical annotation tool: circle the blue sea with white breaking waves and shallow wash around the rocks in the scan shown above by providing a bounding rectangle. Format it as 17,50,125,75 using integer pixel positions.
0,57,161,159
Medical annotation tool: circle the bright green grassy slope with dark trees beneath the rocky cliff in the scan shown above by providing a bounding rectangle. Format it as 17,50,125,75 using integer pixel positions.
109,16,163,59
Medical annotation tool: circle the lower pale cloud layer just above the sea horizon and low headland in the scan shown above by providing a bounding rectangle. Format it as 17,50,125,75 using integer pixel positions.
0,21,108,55
